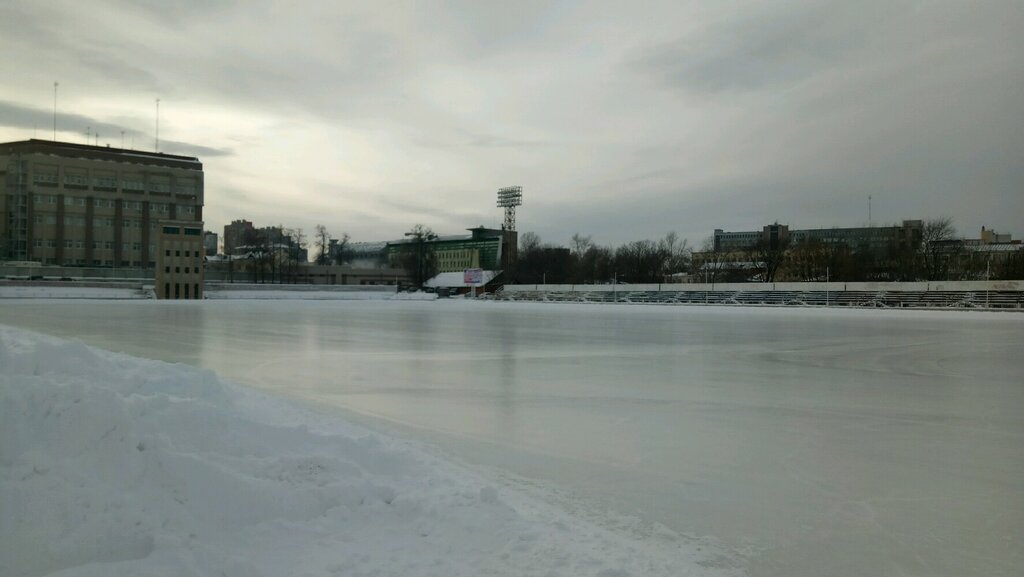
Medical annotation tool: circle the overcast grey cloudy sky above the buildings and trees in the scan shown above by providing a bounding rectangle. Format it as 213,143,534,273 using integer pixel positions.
0,0,1024,245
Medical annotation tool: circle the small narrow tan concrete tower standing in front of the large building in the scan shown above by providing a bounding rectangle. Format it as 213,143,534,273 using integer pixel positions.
154,220,205,299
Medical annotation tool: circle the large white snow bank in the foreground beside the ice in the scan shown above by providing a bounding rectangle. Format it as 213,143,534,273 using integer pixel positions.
0,327,735,577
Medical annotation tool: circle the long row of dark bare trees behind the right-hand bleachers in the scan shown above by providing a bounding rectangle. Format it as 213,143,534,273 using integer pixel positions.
511,218,1024,284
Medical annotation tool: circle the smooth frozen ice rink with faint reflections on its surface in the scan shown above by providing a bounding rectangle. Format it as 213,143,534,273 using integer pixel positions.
0,300,1024,577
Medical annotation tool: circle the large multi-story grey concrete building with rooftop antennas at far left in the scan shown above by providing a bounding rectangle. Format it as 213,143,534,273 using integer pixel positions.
0,139,203,269
